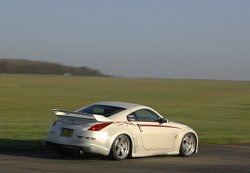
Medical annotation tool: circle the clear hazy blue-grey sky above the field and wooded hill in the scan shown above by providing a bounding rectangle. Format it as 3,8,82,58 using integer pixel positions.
0,0,250,80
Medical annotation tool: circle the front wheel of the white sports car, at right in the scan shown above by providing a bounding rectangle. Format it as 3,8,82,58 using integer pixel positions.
180,133,196,157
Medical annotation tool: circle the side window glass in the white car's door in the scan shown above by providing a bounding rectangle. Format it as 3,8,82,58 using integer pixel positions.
134,109,160,122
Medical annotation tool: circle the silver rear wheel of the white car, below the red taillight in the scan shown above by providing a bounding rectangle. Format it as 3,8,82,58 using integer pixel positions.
110,135,131,160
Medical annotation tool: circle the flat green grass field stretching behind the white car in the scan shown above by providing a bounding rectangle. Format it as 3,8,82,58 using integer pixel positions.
0,74,250,148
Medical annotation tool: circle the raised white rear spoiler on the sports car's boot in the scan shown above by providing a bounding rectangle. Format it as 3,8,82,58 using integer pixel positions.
52,109,111,121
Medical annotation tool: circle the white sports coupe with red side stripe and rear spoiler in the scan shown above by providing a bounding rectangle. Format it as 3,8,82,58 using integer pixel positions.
45,102,198,160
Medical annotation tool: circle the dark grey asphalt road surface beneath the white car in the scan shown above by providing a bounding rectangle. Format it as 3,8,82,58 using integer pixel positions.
0,144,250,173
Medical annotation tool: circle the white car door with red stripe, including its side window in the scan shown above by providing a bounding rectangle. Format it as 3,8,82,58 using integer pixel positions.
134,109,173,150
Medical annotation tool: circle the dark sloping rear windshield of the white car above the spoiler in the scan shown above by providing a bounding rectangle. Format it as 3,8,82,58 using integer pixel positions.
77,105,125,117
